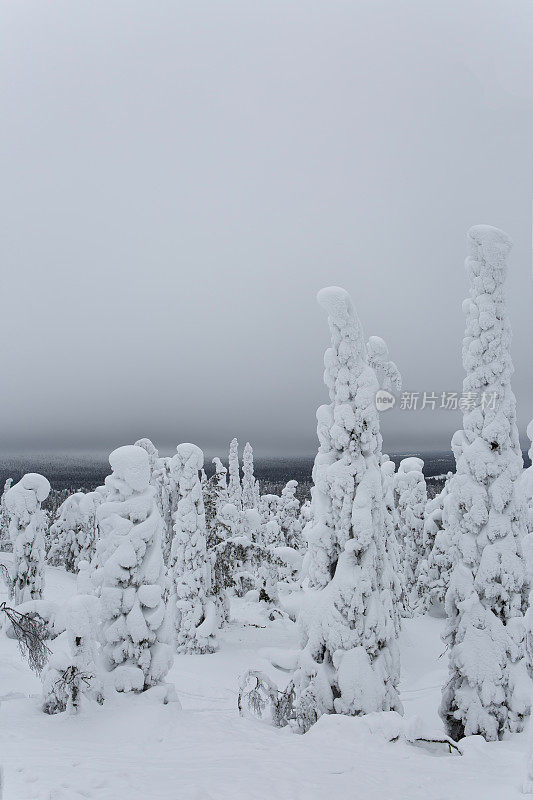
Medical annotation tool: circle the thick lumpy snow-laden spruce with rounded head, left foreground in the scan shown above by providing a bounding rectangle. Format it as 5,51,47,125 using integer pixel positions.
97,445,172,691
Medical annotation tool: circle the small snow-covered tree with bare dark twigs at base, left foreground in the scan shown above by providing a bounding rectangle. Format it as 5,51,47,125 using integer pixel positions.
42,595,104,714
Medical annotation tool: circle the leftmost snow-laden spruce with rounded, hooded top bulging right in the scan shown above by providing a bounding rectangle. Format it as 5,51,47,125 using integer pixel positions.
5,472,50,605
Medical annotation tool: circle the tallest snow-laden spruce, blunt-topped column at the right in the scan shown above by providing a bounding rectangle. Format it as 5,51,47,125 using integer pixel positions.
440,225,531,741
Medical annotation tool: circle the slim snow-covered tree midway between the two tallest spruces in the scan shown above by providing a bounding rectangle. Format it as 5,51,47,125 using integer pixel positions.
394,457,428,608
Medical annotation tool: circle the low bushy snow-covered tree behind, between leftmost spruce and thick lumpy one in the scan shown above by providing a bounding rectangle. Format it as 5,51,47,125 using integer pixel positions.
48,492,97,572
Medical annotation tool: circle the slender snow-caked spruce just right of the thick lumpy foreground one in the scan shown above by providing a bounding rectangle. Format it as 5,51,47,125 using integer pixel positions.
170,443,218,653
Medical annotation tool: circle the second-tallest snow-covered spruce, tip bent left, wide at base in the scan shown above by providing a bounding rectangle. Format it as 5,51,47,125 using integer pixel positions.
294,287,401,731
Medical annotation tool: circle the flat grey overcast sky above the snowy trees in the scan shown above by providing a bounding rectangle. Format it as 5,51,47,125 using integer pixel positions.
0,0,533,455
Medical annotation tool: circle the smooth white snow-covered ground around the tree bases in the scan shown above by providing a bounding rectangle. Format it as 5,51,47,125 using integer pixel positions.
0,554,527,800
